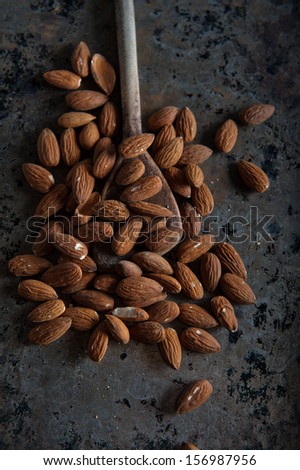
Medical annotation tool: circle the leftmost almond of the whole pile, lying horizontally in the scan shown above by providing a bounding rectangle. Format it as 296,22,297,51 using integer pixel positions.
8,255,52,276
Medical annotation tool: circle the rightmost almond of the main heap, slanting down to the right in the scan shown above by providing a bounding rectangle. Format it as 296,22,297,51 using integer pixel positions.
220,273,256,304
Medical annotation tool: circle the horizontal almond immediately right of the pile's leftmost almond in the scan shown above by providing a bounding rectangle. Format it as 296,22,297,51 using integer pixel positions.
41,262,82,287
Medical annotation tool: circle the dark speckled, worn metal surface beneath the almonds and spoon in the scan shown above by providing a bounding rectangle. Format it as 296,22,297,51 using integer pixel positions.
0,0,300,449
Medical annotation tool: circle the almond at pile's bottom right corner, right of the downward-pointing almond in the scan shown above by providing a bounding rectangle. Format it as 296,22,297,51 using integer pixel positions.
180,326,221,353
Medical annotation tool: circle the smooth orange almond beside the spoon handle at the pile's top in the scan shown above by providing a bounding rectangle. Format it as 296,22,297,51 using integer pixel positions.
91,54,116,95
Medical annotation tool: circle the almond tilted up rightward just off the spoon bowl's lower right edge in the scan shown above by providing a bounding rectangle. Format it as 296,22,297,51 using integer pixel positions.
177,234,215,263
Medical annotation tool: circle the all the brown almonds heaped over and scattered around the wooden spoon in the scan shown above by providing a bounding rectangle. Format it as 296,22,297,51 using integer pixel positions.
8,42,274,432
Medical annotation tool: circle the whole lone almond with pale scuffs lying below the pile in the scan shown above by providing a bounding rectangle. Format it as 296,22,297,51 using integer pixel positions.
176,380,213,414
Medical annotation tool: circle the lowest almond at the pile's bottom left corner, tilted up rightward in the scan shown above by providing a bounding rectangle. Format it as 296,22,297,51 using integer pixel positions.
28,317,72,346
